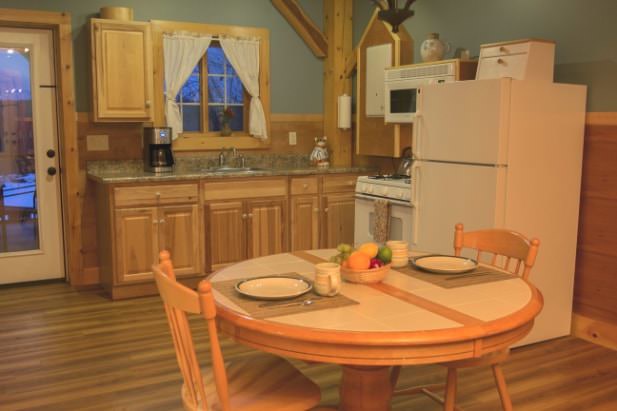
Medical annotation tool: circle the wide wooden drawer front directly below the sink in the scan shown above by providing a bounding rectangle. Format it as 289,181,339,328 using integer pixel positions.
203,178,287,201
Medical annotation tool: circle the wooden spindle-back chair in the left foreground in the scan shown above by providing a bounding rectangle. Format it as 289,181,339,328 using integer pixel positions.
153,251,321,411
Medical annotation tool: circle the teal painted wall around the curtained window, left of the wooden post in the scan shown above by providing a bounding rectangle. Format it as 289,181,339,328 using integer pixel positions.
0,0,323,113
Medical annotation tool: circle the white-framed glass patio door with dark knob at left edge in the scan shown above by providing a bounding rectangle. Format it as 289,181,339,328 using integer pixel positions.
0,27,64,284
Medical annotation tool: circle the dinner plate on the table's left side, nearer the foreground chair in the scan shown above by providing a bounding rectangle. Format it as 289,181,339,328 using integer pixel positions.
235,276,313,300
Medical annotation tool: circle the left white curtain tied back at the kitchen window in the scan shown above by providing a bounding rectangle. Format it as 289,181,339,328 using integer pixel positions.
163,33,212,140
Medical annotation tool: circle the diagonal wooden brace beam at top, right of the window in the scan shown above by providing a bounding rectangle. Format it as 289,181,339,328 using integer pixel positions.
272,0,328,58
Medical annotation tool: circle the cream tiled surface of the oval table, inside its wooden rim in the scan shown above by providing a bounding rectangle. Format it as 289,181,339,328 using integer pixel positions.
211,250,532,332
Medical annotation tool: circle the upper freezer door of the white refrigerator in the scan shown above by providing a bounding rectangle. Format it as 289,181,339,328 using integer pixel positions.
413,79,512,164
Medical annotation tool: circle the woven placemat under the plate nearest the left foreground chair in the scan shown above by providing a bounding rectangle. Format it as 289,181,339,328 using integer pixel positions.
212,273,358,318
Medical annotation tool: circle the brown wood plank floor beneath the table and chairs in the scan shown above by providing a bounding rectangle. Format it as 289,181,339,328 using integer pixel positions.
0,283,617,411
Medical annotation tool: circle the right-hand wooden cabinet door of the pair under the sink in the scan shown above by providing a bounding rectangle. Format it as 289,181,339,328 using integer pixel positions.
247,199,287,258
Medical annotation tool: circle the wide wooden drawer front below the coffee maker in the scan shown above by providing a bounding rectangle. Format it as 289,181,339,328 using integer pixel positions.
114,184,199,207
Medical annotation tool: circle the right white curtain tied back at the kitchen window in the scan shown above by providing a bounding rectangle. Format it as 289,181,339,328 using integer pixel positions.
219,37,268,140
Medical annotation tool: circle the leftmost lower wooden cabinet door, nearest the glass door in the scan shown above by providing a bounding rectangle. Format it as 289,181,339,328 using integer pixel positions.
115,207,159,283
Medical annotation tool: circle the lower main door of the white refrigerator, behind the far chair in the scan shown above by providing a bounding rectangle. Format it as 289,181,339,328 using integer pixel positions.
412,161,507,254
